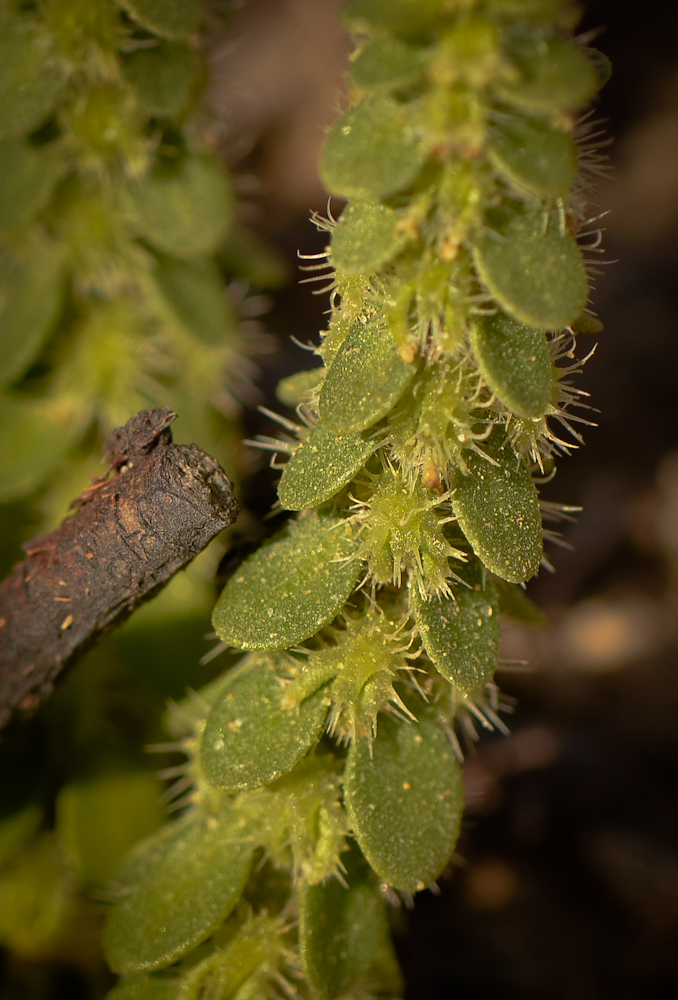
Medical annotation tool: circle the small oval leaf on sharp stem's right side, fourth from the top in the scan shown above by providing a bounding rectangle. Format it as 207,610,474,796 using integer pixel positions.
470,313,553,419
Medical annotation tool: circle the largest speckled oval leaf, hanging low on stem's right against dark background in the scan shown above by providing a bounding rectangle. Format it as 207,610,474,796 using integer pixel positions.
344,715,463,892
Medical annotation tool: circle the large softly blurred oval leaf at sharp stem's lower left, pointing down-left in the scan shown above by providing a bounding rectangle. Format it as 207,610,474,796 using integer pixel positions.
103,810,254,973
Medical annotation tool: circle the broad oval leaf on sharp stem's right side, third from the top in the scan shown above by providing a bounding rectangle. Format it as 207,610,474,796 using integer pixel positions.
473,206,588,330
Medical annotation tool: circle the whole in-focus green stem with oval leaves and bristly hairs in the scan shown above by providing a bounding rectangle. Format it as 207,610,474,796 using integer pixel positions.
105,0,608,1000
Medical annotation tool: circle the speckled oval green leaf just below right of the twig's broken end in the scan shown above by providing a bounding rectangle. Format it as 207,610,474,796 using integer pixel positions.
212,512,361,649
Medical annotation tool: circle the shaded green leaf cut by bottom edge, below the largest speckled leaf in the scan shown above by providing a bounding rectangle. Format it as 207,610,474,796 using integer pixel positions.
299,852,388,1000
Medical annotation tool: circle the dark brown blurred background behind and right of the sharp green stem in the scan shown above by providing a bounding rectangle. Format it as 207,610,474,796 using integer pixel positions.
212,0,678,1000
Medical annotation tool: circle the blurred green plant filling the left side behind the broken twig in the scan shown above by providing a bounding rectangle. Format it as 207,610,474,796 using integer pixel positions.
0,0,285,996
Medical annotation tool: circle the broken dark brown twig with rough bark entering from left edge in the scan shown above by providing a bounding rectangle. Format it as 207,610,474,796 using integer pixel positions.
0,409,238,730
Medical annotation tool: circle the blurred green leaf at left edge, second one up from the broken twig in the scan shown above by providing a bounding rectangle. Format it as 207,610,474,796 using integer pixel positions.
0,246,64,386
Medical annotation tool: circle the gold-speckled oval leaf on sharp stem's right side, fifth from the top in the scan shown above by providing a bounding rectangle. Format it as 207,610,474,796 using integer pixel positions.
452,429,542,583
